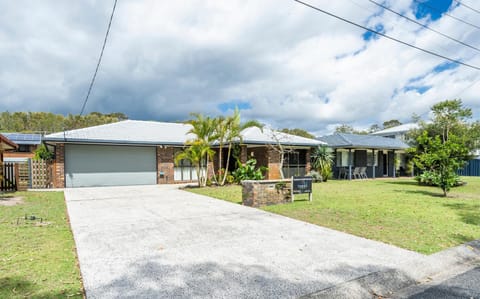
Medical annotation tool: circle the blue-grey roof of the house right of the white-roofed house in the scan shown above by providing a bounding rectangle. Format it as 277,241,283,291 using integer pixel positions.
319,133,409,149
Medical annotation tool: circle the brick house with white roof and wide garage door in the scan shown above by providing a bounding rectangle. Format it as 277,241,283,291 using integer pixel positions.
43,120,324,187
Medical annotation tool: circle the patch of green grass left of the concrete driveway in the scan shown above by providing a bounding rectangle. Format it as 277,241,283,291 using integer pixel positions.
0,192,83,298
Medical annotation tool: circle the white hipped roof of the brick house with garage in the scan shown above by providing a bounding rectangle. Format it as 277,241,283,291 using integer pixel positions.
44,120,323,146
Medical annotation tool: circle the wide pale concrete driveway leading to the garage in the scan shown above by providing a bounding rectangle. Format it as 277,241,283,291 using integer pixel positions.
65,185,424,298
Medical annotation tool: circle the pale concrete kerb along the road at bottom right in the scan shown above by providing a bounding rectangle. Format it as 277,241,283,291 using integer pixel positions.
301,240,480,299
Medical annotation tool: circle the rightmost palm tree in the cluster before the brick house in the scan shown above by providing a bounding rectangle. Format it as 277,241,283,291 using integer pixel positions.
217,108,263,186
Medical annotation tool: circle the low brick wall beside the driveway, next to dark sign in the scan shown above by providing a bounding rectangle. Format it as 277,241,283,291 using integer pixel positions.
242,179,292,207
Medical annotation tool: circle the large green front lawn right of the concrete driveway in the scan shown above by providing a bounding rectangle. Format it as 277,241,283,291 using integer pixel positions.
191,177,480,254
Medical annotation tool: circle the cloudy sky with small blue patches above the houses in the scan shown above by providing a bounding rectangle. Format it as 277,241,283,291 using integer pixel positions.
0,0,480,136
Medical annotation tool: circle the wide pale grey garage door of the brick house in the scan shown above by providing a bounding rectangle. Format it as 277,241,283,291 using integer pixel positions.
65,144,157,187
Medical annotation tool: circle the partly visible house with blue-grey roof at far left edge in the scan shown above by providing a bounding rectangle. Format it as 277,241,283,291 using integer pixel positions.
2,133,42,162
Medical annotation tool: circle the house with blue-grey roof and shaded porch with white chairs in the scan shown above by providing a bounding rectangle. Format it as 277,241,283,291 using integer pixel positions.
319,133,409,179
